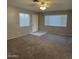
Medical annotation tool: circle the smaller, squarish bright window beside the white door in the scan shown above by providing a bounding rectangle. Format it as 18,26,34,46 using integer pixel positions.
19,13,30,27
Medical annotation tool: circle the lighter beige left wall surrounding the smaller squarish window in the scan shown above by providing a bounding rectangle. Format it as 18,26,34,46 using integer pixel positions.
7,5,35,39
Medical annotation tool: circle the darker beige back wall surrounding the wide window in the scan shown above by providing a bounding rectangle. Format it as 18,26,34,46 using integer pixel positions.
39,10,72,35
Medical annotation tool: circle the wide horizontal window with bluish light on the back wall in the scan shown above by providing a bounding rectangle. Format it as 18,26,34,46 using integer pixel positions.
45,15,67,27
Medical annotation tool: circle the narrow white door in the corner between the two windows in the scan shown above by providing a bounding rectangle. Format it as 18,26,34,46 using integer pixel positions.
32,14,38,32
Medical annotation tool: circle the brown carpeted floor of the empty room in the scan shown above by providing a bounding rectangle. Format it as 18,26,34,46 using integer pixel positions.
7,34,72,59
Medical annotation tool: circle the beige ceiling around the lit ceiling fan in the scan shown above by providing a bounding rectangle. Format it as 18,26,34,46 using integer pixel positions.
7,0,72,12
